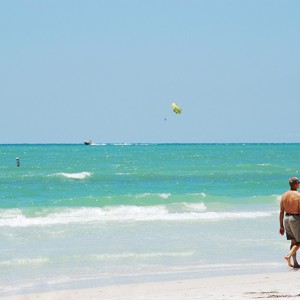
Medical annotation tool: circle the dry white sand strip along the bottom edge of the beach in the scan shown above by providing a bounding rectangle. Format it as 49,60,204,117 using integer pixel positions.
1,269,300,300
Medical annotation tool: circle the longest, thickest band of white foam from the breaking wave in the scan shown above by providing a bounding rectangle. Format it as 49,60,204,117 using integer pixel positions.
0,203,277,227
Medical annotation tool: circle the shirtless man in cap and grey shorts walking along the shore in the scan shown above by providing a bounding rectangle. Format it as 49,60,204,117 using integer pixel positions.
279,177,300,268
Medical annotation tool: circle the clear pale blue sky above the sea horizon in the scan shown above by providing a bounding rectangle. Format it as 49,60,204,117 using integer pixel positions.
0,0,300,143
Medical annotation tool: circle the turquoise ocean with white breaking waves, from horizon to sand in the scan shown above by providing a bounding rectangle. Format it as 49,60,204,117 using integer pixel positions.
0,144,300,296
